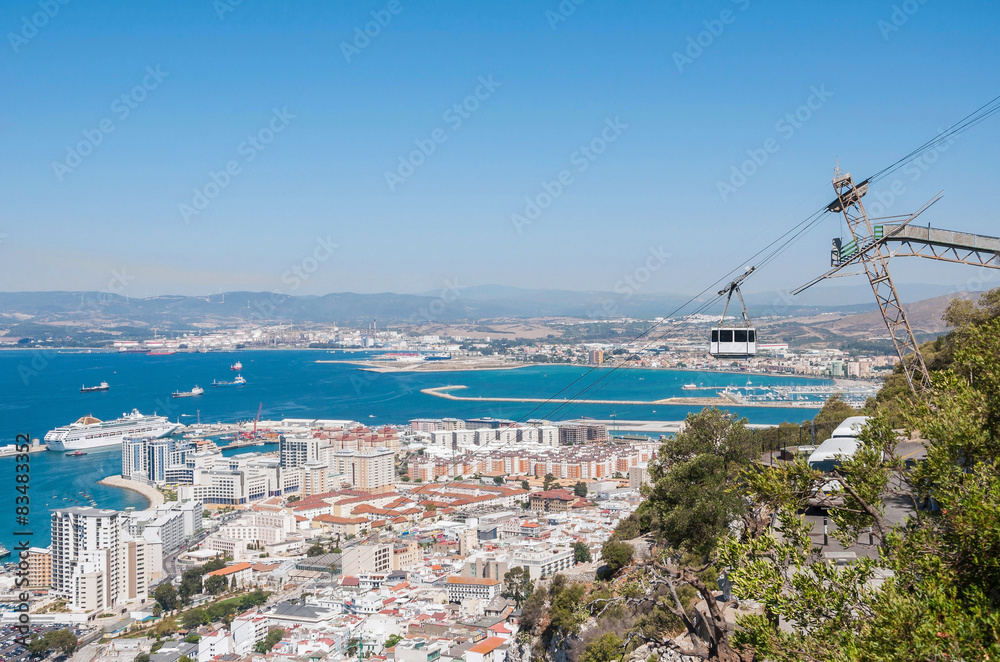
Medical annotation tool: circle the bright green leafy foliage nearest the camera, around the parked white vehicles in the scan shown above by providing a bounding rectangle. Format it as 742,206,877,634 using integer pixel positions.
720,319,1000,662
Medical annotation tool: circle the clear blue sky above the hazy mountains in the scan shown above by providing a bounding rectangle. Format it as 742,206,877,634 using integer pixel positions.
0,0,1000,303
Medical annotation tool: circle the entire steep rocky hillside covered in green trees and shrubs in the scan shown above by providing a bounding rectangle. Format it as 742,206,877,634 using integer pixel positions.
514,290,1000,662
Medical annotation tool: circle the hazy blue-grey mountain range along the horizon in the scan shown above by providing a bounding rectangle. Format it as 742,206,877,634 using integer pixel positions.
0,285,984,335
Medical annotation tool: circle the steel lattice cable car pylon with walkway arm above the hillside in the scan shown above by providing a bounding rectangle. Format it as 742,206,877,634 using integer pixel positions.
792,166,1000,393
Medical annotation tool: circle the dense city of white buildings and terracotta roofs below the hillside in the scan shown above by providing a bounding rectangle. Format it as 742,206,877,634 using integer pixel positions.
15,410,659,662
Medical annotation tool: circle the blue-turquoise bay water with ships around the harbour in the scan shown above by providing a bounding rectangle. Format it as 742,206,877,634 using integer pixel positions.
0,350,822,549
